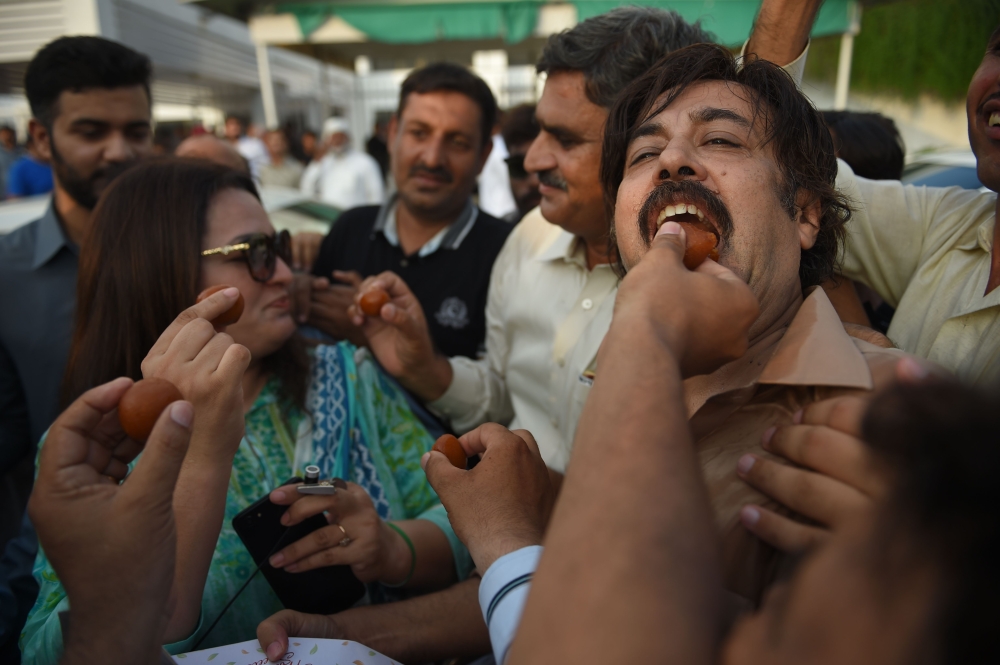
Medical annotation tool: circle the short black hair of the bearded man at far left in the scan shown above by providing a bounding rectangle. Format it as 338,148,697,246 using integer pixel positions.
24,37,153,130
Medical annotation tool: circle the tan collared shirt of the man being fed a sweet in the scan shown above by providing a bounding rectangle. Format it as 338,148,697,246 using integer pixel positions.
684,288,906,600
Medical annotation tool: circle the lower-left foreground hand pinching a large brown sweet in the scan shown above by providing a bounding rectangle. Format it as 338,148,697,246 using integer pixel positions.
28,378,194,663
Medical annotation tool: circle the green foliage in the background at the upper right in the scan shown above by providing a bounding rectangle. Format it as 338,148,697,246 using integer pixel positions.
806,0,1000,101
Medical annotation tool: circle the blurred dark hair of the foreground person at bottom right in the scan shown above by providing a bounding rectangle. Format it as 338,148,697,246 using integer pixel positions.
862,379,1000,665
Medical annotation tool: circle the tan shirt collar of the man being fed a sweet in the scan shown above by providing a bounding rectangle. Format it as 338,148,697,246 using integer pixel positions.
685,287,875,416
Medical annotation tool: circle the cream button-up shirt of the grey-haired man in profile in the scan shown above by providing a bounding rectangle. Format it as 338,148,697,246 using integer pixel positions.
431,208,618,471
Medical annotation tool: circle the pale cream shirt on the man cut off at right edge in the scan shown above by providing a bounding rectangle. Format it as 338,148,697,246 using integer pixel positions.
837,161,1000,383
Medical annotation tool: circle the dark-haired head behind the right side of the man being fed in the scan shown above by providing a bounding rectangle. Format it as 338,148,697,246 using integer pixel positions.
823,111,906,180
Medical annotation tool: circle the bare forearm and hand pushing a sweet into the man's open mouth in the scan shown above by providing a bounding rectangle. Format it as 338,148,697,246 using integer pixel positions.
507,222,757,664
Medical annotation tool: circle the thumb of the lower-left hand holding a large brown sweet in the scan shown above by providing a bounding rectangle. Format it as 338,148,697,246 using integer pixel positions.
122,401,194,502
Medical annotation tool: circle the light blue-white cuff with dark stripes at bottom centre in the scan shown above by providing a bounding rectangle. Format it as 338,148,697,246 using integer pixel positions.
479,545,543,665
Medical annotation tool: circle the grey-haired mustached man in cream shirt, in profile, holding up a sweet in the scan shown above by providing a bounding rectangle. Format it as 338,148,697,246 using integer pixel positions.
340,0,816,473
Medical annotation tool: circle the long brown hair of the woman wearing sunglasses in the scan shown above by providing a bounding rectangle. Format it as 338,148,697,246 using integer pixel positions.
61,158,309,406
